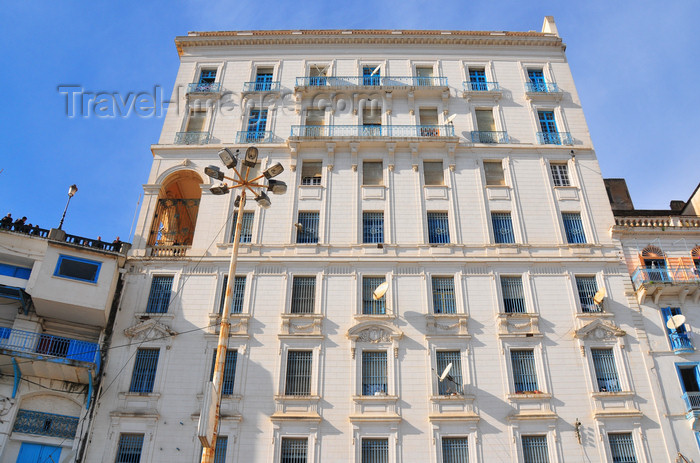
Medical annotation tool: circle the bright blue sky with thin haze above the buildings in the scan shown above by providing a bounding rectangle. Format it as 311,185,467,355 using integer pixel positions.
0,0,700,241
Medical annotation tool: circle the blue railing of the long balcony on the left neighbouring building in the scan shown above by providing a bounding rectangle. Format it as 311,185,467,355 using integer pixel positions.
0,328,100,370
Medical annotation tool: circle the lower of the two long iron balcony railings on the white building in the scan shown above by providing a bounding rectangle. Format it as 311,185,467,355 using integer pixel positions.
291,125,455,137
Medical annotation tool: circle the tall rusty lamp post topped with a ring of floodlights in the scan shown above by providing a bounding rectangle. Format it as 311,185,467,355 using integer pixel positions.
198,146,287,463
